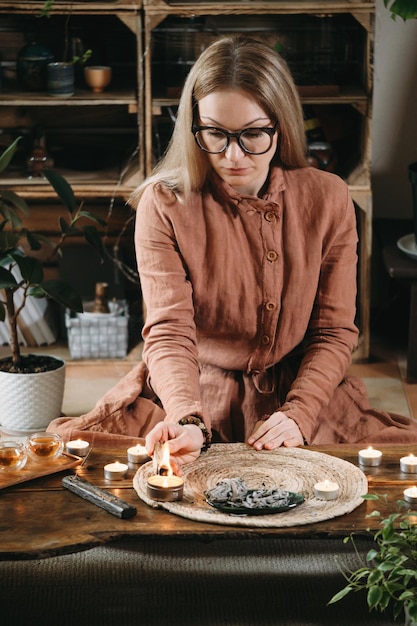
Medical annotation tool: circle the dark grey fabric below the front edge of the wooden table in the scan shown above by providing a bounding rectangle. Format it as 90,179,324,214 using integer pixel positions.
0,537,396,626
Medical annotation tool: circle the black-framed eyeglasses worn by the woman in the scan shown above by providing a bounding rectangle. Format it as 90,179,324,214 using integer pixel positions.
191,122,278,154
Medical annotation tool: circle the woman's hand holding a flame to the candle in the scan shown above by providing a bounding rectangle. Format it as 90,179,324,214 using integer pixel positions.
145,422,204,473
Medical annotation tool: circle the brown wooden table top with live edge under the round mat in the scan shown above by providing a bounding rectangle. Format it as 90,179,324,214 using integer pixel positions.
0,445,417,561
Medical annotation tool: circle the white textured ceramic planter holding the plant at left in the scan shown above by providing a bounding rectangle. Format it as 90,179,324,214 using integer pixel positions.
0,357,65,435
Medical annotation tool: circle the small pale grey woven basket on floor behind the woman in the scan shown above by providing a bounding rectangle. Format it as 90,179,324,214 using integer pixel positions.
65,300,128,359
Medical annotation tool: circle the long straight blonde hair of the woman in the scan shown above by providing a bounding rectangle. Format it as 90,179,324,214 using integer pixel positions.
131,35,306,204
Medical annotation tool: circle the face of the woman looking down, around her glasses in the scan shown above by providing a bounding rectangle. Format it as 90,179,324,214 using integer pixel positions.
196,90,278,196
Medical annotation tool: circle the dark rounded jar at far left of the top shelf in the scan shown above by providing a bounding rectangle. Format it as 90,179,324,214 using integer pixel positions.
16,41,54,91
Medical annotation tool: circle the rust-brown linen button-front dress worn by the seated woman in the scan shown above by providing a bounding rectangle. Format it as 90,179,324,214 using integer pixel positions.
49,167,417,444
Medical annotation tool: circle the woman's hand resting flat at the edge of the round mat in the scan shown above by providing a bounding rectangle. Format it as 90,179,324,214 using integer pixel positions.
247,411,304,450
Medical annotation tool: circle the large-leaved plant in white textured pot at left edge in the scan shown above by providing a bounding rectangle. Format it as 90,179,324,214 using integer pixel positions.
0,138,106,432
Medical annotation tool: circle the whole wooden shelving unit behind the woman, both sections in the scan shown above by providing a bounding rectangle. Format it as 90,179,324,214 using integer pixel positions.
0,0,375,361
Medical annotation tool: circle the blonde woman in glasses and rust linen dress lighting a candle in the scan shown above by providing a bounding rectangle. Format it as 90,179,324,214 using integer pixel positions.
50,37,417,463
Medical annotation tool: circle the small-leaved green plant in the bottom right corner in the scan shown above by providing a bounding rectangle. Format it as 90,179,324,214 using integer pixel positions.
329,494,417,626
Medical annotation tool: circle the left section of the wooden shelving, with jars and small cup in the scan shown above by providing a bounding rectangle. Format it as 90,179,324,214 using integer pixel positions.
0,0,144,199
